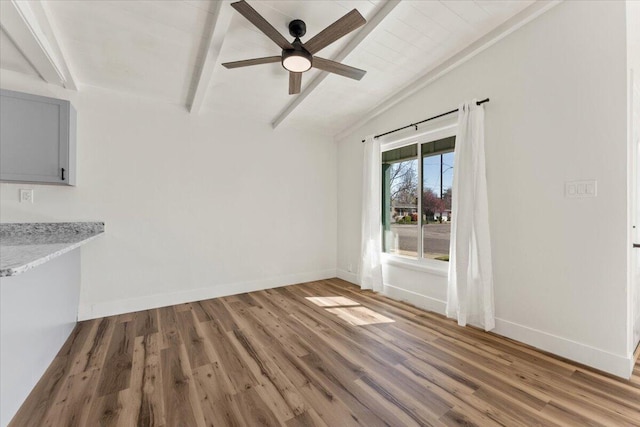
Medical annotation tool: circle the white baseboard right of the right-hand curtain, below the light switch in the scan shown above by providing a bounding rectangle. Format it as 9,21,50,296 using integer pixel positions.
491,318,634,379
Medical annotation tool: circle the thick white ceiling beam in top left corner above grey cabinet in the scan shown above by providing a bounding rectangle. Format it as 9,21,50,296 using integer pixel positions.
0,0,77,90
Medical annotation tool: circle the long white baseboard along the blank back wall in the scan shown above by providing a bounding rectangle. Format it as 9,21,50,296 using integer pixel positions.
78,269,336,321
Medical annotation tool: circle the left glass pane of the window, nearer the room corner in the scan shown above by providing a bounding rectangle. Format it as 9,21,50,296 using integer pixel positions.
382,149,419,257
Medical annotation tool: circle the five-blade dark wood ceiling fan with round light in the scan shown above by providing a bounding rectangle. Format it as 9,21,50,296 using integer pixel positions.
222,0,367,95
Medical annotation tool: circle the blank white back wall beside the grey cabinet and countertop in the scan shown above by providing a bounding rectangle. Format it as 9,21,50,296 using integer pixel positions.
0,70,336,319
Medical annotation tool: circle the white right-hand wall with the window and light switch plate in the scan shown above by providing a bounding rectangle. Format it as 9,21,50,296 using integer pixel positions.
338,1,630,376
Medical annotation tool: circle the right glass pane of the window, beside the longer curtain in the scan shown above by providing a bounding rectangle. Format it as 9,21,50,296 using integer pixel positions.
422,147,454,261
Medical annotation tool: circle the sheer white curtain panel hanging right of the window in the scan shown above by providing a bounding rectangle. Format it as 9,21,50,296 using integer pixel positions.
447,99,495,331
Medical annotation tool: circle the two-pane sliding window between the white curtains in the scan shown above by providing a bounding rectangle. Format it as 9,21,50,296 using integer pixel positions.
382,136,455,261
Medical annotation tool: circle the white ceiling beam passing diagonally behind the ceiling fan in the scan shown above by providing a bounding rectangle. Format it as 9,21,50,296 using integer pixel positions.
271,0,400,129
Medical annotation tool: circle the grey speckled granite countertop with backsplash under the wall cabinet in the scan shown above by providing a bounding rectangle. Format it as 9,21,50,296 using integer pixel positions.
0,222,104,277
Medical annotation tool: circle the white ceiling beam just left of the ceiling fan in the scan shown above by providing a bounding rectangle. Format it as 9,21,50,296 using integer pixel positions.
187,0,233,113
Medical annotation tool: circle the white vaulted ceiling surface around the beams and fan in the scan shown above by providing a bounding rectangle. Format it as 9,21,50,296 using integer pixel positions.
0,0,533,134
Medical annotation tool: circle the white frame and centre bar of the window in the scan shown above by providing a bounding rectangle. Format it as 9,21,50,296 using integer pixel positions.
380,118,458,275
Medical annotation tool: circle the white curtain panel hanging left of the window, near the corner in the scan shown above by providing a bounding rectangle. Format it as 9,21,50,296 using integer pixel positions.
358,135,382,292
